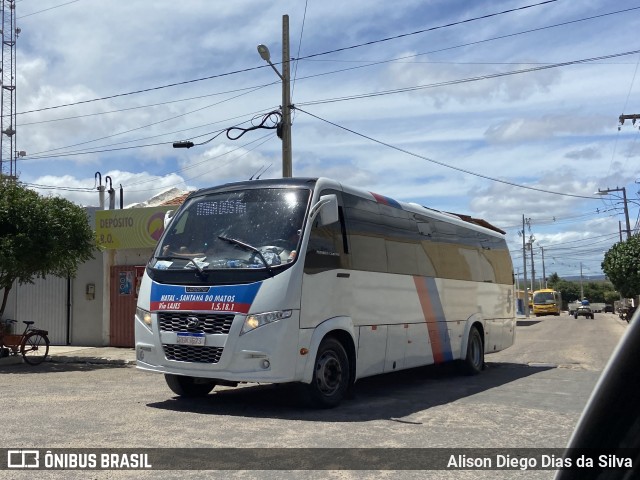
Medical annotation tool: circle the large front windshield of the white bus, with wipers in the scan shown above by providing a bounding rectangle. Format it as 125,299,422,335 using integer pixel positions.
150,188,311,272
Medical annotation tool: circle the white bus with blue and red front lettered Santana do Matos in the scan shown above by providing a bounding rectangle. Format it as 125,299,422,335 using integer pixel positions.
135,178,515,408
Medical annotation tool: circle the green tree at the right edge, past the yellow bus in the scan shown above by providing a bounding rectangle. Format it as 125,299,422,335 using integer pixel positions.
602,235,640,298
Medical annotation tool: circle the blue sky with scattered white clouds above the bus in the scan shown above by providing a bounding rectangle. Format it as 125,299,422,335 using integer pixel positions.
3,0,640,279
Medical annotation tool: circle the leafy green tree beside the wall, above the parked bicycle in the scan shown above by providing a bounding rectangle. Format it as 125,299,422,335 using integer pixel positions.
0,177,96,317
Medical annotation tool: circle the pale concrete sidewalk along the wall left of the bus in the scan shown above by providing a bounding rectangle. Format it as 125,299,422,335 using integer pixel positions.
0,345,136,366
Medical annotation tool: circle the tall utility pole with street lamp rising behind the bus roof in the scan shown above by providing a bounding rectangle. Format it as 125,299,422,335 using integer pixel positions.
258,15,293,178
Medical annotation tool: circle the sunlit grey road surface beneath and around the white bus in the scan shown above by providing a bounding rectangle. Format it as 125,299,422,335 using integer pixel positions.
0,314,627,479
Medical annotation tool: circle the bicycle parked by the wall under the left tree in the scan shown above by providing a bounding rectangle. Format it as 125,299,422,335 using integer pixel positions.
0,320,50,365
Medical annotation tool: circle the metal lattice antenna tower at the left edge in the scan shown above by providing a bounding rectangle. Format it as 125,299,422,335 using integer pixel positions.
0,0,20,179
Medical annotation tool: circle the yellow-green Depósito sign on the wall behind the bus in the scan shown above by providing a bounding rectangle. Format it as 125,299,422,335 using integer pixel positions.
96,205,176,250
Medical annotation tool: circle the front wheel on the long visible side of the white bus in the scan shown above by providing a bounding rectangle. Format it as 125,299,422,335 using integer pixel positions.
306,337,351,408
